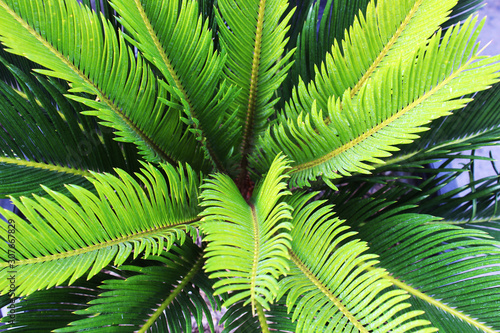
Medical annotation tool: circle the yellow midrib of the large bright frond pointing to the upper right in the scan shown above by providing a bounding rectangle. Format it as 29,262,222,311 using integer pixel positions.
289,57,476,174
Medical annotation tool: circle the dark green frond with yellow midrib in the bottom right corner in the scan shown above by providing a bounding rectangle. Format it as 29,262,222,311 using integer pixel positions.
359,213,500,332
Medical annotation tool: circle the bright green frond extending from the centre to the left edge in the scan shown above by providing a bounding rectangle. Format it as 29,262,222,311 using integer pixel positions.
0,165,200,295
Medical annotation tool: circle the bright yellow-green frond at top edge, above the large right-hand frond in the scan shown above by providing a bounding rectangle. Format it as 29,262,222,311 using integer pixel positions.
278,0,457,116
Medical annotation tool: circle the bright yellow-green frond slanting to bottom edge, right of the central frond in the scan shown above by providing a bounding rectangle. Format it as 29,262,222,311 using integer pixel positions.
280,193,436,332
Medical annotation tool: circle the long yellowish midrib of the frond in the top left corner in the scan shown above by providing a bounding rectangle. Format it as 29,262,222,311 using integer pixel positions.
0,1,177,165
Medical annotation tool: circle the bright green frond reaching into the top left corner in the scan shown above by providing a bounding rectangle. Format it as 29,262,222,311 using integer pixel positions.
0,0,203,168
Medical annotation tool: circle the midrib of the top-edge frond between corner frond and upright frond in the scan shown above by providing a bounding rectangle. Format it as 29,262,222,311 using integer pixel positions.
134,0,226,173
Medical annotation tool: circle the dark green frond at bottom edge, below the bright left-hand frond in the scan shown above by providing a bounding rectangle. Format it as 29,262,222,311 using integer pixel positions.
55,240,215,332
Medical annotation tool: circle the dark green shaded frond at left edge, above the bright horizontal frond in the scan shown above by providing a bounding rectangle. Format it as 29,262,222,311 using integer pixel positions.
0,59,140,197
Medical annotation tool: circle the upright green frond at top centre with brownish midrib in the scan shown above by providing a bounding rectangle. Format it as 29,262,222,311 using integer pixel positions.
217,0,293,176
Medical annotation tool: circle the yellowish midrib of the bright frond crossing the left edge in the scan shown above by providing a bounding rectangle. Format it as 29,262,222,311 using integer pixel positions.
0,217,200,268
